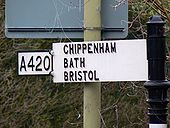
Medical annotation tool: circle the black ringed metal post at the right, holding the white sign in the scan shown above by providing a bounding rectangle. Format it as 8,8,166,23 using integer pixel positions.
144,16,170,128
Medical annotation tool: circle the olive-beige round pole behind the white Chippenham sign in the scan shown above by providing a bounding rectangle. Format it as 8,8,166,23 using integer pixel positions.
83,0,101,128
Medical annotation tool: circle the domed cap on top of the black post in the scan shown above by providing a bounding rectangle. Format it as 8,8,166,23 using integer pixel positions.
147,15,165,24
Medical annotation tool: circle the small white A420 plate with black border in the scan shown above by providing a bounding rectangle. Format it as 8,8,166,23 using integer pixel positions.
17,50,53,75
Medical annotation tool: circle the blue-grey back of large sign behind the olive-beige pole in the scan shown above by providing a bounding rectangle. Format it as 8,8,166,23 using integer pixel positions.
5,0,128,39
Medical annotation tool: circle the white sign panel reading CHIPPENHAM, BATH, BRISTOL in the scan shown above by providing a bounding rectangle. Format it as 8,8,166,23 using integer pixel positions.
53,39,148,83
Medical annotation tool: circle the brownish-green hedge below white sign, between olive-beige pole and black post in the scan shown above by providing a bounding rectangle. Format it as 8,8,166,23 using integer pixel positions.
101,82,147,128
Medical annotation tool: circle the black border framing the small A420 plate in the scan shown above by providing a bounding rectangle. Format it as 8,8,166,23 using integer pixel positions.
17,50,54,76
